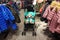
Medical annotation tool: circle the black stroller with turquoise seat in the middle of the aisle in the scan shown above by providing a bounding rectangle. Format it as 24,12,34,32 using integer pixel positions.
22,6,36,36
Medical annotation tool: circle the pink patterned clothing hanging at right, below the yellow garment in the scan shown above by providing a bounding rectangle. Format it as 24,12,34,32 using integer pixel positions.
43,6,60,33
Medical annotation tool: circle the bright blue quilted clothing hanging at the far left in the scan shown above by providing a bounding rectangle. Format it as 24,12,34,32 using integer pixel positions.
0,5,17,32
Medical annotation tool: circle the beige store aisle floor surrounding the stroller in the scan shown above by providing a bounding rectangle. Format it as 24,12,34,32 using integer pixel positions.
7,9,51,40
